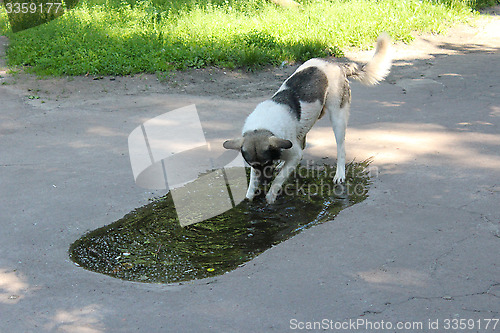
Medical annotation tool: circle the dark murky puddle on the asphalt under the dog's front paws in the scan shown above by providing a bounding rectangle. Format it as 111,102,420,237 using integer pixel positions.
69,161,370,283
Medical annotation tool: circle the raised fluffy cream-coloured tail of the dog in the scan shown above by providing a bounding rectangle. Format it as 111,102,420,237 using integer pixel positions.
344,33,392,86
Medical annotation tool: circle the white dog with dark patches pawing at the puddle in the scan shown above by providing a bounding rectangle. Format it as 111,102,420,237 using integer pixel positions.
223,33,392,204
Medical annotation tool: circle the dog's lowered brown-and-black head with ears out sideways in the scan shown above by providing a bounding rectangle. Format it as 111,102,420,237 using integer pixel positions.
223,130,292,181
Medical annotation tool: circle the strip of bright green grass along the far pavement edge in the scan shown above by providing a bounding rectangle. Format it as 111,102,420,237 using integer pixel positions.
0,0,487,75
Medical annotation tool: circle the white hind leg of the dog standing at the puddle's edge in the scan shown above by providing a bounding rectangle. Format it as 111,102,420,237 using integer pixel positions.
328,103,349,183
